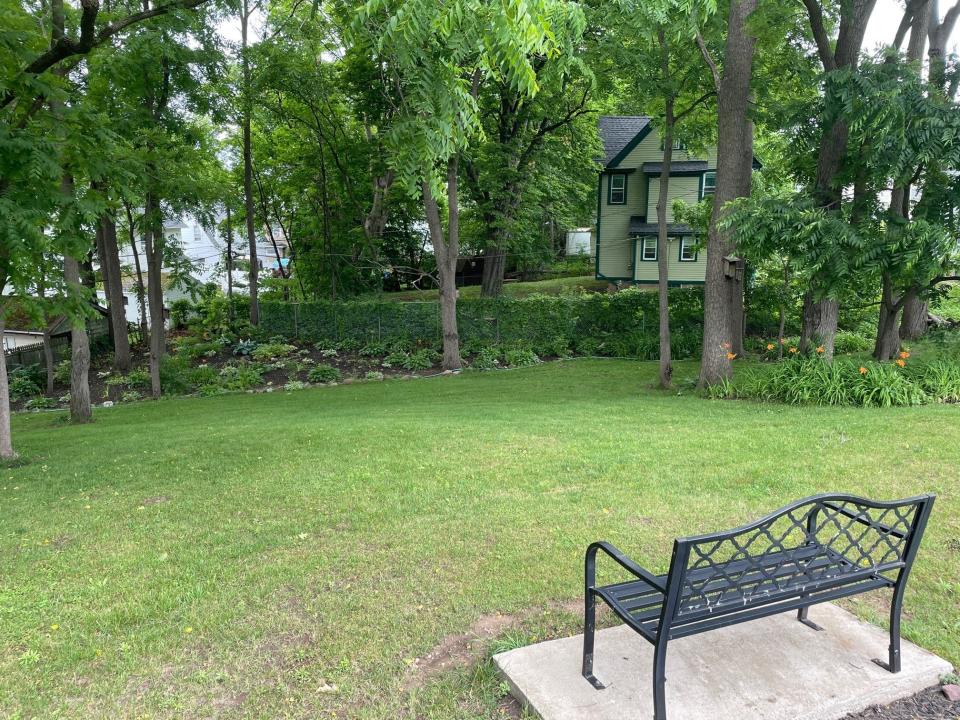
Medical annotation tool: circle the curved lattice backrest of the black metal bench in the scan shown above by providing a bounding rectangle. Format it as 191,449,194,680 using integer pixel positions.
664,494,934,621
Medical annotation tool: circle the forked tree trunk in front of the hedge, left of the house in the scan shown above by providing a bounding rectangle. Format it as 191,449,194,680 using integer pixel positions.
422,155,463,370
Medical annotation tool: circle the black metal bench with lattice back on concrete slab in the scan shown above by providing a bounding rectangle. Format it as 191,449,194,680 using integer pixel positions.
583,495,934,720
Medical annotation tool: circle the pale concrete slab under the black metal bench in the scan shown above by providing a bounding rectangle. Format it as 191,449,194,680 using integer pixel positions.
493,604,951,720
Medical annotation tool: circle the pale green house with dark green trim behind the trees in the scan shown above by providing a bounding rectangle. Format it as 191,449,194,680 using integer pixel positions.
595,115,717,285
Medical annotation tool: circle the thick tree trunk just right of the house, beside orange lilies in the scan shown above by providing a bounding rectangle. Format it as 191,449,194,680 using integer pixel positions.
698,0,757,387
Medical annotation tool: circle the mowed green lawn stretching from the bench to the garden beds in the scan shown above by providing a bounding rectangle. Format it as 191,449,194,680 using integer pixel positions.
0,360,960,720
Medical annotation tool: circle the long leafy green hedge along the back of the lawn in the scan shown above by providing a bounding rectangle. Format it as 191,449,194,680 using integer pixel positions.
260,288,703,357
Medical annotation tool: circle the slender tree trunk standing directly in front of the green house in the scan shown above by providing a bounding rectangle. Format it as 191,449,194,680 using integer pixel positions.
657,45,675,390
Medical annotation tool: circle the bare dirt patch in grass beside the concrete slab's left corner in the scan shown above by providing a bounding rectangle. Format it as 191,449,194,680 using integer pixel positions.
403,600,583,692
